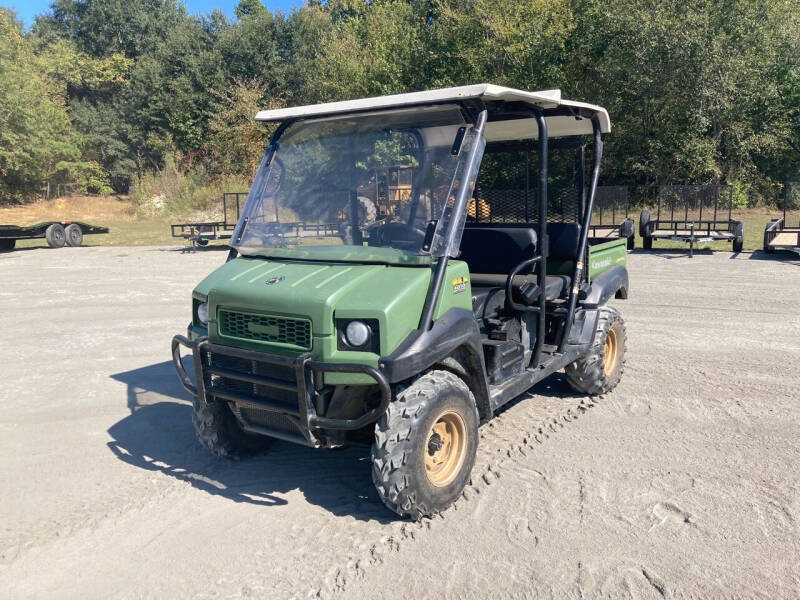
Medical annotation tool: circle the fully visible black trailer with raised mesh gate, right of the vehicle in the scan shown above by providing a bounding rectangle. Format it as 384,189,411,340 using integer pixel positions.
639,185,744,257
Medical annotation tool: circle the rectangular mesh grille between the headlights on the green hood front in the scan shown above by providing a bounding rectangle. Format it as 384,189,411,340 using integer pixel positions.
219,308,311,350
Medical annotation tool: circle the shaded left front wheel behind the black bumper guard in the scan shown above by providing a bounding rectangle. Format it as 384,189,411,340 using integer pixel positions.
192,398,272,459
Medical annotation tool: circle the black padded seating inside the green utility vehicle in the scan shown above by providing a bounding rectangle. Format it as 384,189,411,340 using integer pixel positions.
459,223,580,318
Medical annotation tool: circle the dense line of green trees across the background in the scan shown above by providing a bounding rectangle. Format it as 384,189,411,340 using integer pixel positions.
0,0,800,202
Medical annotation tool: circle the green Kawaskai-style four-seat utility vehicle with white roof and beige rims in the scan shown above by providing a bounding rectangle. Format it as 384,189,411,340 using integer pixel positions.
172,84,628,519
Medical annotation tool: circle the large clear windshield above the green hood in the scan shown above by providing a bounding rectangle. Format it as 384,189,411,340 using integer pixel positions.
232,106,483,263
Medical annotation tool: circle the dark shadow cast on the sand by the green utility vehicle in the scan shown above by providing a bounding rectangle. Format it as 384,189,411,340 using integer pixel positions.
108,361,397,523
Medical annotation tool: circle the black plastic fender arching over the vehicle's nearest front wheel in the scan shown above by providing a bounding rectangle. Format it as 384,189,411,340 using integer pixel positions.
378,308,490,420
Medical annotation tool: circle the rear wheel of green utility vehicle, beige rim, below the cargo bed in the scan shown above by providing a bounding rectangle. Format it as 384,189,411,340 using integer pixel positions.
565,307,627,396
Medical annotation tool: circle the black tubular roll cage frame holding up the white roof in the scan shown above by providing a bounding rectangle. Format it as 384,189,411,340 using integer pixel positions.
233,99,603,367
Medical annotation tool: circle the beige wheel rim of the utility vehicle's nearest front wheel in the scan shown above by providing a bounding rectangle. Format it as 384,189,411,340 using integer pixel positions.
425,411,467,487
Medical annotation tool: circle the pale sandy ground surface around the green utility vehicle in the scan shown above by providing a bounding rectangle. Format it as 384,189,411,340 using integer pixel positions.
0,248,800,600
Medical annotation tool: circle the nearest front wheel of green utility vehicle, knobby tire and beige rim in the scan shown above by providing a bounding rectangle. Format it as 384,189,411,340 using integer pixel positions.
372,371,478,520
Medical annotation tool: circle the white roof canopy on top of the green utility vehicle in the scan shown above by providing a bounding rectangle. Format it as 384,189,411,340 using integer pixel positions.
256,83,611,142
